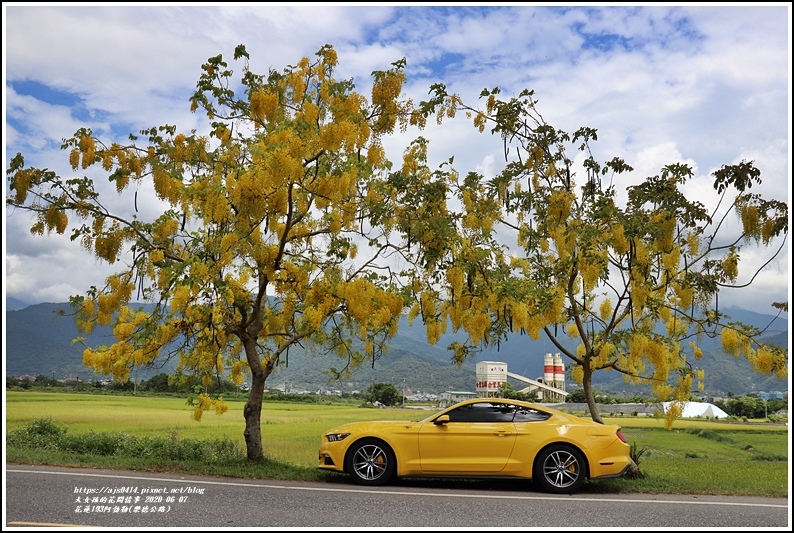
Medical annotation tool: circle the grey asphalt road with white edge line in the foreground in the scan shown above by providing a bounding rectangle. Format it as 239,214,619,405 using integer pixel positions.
3,465,791,531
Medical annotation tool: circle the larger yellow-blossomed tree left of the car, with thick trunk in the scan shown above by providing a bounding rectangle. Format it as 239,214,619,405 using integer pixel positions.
7,45,421,460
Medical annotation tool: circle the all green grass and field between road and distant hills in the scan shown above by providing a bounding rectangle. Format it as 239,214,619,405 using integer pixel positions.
6,391,789,497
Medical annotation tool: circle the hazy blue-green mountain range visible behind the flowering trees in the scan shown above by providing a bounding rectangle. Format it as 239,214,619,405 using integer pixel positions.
4,299,789,395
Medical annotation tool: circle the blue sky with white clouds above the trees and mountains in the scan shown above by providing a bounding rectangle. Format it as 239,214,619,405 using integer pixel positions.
3,2,791,313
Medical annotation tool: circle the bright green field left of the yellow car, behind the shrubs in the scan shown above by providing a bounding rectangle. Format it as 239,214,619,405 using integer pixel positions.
6,392,420,467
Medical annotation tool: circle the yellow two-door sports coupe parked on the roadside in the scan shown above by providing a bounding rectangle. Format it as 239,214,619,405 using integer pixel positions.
319,398,632,494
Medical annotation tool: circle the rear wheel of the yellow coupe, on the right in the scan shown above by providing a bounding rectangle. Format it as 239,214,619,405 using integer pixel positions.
532,444,587,494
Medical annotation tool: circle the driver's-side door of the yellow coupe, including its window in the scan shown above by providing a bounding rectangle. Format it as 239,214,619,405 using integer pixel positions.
419,401,516,474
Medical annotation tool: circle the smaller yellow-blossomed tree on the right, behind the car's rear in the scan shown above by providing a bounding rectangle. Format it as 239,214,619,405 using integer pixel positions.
410,84,788,427
